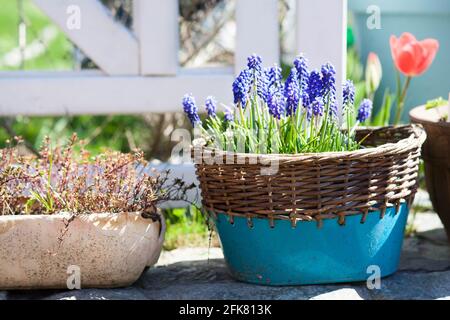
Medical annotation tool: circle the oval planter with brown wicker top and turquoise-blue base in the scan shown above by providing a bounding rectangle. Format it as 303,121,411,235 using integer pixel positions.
194,125,425,285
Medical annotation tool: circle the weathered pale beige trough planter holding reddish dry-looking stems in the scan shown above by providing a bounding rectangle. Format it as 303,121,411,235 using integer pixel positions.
0,213,165,290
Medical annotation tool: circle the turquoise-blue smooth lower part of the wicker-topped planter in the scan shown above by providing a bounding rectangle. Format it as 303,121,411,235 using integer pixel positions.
214,203,409,285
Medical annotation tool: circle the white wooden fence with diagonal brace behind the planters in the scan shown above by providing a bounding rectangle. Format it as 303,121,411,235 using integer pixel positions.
0,0,347,208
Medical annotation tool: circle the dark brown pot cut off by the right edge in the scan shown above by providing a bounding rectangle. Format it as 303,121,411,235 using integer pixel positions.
409,106,450,241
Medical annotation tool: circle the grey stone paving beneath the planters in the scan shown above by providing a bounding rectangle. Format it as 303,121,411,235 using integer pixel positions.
0,213,450,300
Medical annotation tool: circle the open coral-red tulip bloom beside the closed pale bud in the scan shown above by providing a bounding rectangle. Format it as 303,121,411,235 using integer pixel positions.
390,32,439,77
